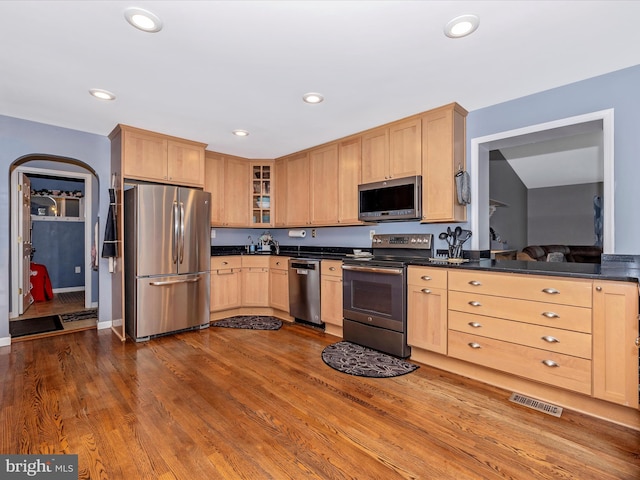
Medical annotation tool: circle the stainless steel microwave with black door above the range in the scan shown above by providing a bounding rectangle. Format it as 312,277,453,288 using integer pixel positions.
358,175,422,222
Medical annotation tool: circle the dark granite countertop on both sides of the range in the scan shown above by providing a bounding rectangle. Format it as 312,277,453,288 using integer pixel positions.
211,246,640,282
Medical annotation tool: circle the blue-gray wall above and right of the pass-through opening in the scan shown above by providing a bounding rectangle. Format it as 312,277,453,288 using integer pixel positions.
467,65,640,255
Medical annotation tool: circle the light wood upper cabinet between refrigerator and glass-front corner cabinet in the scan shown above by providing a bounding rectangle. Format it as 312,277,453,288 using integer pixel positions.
205,151,252,227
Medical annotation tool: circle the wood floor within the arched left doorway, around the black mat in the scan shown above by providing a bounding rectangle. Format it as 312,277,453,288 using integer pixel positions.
10,292,97,342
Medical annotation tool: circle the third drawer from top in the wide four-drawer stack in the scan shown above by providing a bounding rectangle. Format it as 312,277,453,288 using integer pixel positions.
449,310,591,359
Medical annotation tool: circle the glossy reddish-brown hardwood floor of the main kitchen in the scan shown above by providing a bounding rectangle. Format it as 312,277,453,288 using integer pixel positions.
0,324,640,480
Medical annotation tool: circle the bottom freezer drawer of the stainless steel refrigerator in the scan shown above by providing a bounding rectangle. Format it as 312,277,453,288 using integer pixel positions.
127,272,210,341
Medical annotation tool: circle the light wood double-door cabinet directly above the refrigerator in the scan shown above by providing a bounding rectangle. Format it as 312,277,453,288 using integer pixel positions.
109,125,206,187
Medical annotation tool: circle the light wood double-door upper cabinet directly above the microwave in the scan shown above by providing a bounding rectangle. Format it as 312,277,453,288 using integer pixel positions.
362,117,422,183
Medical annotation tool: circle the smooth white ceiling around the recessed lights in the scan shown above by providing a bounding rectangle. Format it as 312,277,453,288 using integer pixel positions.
0,1,640,158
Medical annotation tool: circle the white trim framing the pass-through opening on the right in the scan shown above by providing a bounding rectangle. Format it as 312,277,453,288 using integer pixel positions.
470,108,615,253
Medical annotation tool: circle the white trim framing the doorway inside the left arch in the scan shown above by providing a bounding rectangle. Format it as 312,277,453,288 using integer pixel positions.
9,166,97,318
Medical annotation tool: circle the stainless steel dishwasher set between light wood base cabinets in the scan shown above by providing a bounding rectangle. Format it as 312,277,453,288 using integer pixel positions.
289,258,322,325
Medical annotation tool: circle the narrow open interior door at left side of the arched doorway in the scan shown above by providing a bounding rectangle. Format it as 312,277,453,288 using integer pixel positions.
18,172,33,315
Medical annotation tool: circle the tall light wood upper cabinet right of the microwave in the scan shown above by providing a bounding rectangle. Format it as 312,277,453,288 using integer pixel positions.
422,103,467,222
